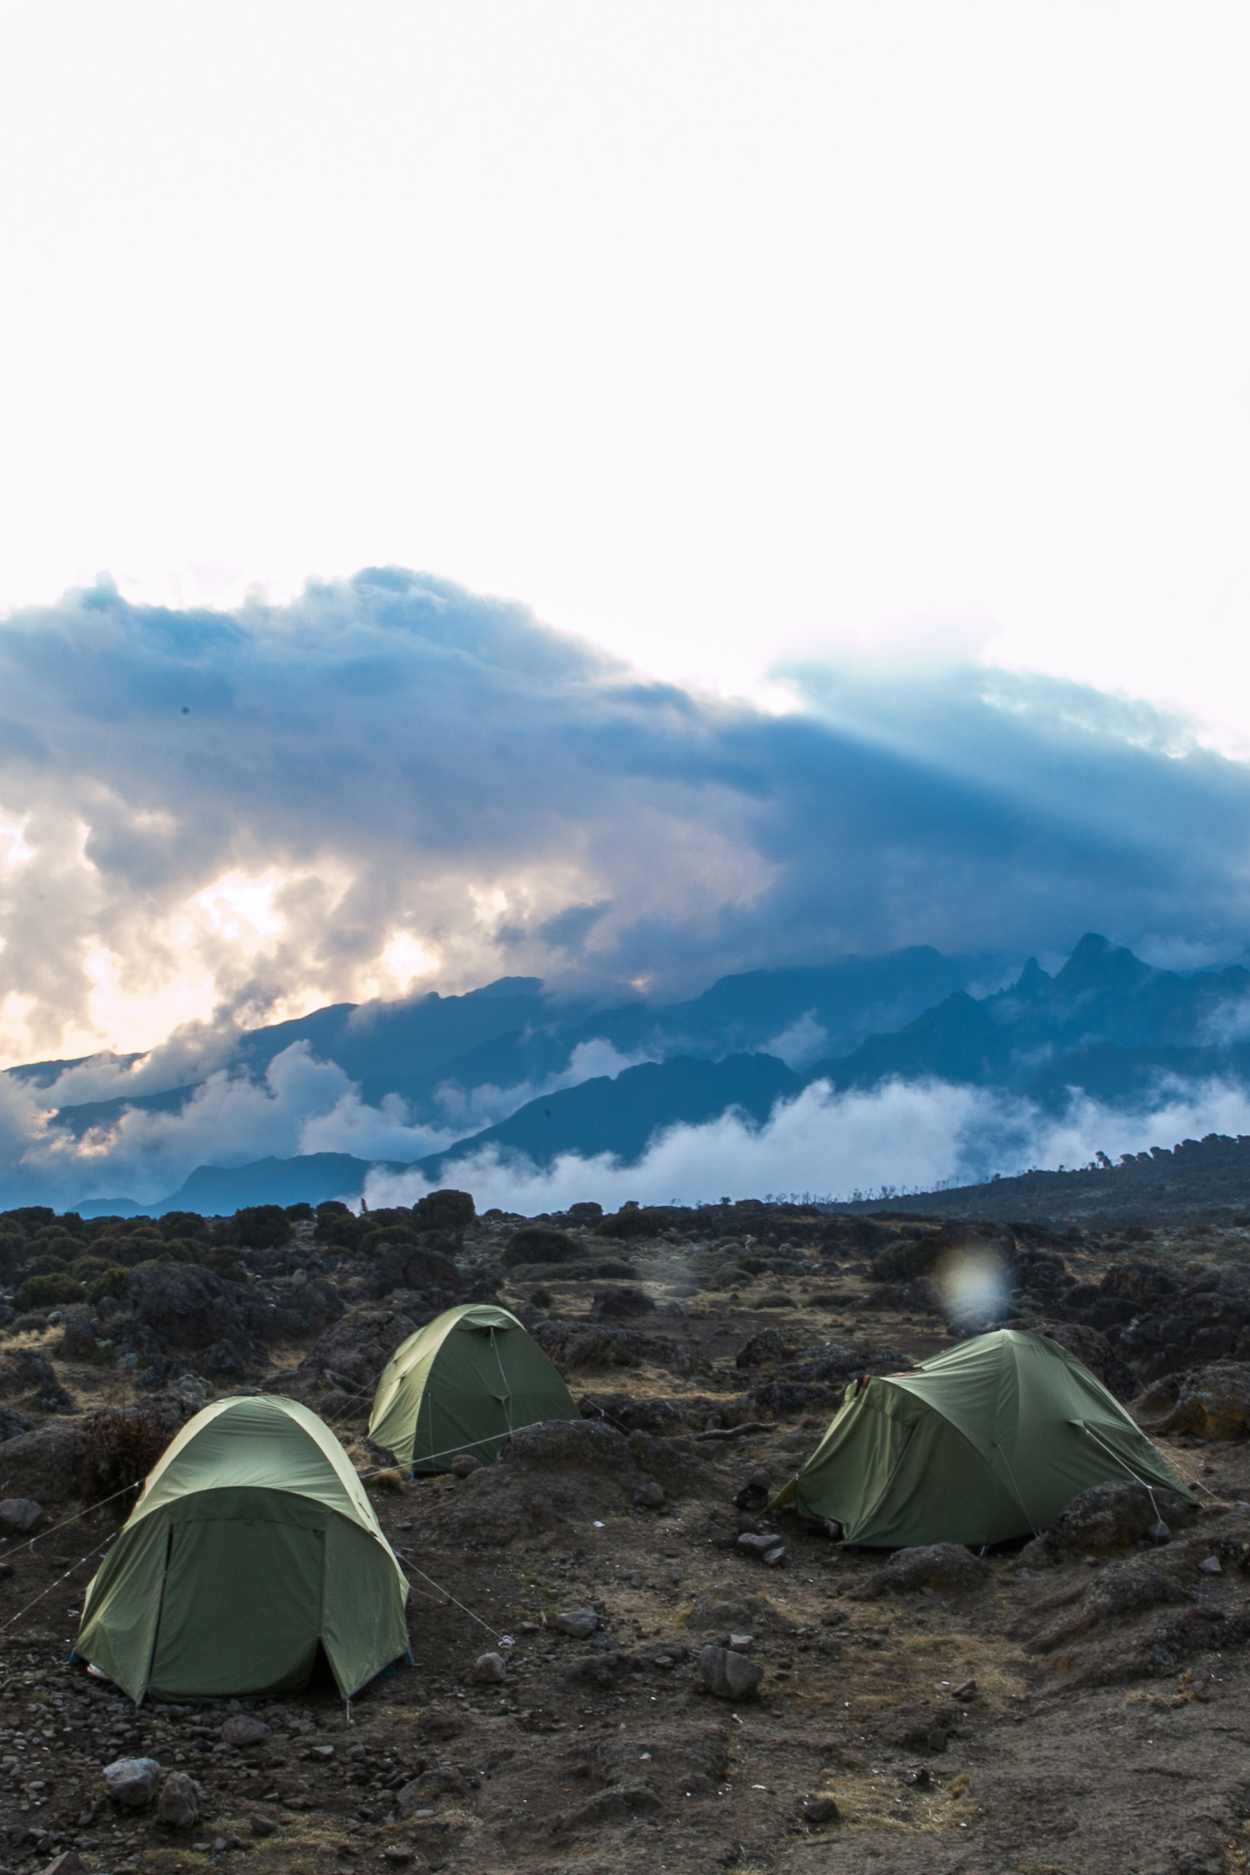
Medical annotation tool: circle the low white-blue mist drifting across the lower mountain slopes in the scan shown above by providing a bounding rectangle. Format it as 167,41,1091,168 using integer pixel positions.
0,1043,1250,1213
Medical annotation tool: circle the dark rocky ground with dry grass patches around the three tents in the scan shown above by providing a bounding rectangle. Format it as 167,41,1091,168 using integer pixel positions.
0,1206,1250,1875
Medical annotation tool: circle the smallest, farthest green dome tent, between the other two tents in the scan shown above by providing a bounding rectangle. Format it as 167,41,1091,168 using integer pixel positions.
369,1303,579,1472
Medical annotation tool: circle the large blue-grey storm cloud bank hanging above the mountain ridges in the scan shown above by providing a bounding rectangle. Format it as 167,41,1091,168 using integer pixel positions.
0,568,1250,1072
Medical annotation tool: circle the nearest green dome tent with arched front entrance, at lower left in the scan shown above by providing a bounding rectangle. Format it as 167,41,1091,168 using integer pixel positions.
75,1395,409,1701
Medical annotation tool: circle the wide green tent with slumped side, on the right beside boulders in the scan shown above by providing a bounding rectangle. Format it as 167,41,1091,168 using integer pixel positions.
774,1328,1192,1549
